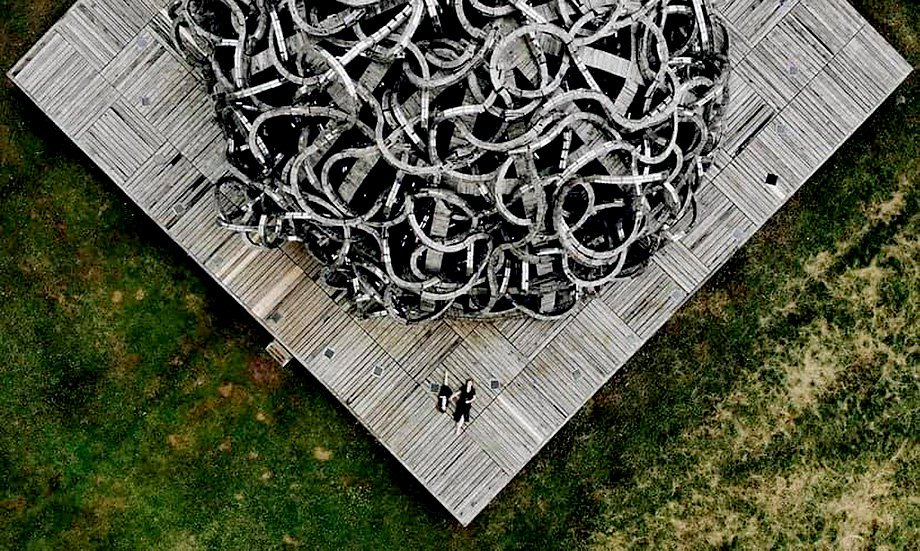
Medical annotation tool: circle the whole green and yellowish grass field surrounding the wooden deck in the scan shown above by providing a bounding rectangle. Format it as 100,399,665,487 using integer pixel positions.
0,0,920,549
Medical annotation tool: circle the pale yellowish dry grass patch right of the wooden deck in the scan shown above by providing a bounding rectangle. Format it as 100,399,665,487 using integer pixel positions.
598,180,920,549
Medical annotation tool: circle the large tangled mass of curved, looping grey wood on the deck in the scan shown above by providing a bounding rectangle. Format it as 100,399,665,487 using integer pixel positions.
171,0,728,322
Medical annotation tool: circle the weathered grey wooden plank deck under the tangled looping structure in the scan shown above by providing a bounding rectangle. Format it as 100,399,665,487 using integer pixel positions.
9,0,911,525
